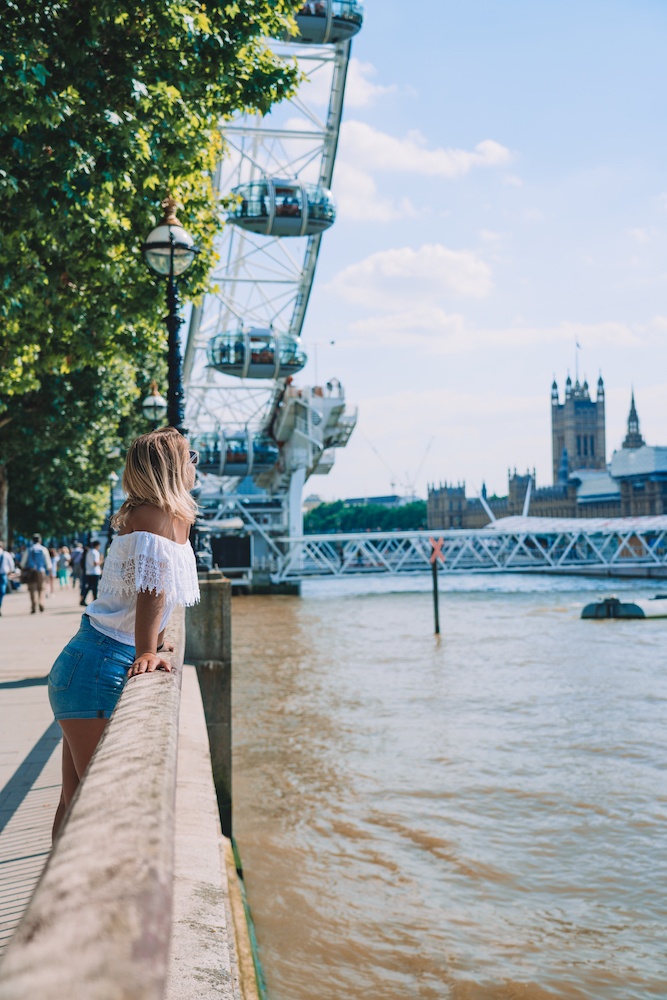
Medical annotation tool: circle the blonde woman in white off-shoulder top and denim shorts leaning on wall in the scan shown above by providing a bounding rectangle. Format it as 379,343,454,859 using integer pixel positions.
49,427,199,837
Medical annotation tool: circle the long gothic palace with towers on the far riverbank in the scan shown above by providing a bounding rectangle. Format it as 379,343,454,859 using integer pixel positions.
428,375,667,528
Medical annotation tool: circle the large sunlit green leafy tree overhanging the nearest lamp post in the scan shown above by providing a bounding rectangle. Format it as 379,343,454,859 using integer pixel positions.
0,0,297,532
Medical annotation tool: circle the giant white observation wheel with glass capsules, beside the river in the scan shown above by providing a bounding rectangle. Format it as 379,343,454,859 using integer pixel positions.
184,0,363,534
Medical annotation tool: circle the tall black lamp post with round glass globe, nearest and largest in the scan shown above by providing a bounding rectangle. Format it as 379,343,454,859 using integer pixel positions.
142,196,199,434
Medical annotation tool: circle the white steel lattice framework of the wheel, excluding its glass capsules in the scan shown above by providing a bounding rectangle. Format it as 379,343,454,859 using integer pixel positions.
184,41,350,444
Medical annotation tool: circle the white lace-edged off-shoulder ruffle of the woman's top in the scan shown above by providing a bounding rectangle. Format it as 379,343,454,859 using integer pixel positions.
100,535,199,607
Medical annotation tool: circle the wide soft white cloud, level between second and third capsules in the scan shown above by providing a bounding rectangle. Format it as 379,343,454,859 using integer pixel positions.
327,243,492,310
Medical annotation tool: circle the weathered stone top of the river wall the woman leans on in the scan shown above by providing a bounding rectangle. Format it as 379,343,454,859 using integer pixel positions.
0,613,184,1000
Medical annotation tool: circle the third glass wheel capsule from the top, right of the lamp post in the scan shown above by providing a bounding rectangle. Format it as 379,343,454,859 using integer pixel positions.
206,329,308,378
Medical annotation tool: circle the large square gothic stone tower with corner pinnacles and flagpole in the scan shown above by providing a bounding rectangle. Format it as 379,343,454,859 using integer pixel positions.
551,375,607,484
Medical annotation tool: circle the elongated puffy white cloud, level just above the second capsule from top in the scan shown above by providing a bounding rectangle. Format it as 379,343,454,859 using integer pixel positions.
340,120,512,180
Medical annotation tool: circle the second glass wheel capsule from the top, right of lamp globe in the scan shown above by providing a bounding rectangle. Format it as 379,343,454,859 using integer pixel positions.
227,177,336,236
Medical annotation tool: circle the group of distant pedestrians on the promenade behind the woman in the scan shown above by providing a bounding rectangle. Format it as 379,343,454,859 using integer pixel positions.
0,534,104,616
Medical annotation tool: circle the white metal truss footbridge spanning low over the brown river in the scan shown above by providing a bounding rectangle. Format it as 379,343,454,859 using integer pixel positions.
273,517,667,582
